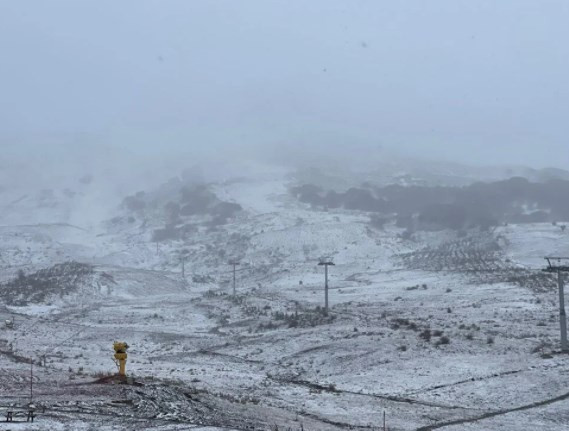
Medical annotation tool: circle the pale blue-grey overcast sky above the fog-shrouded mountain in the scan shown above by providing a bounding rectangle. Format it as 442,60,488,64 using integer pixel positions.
0,0,569,168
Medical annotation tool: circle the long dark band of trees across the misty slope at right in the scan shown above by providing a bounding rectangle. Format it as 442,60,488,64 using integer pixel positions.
292,177,569,230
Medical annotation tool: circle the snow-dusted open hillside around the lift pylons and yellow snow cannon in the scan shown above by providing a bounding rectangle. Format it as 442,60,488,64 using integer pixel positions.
0,173,569,431
